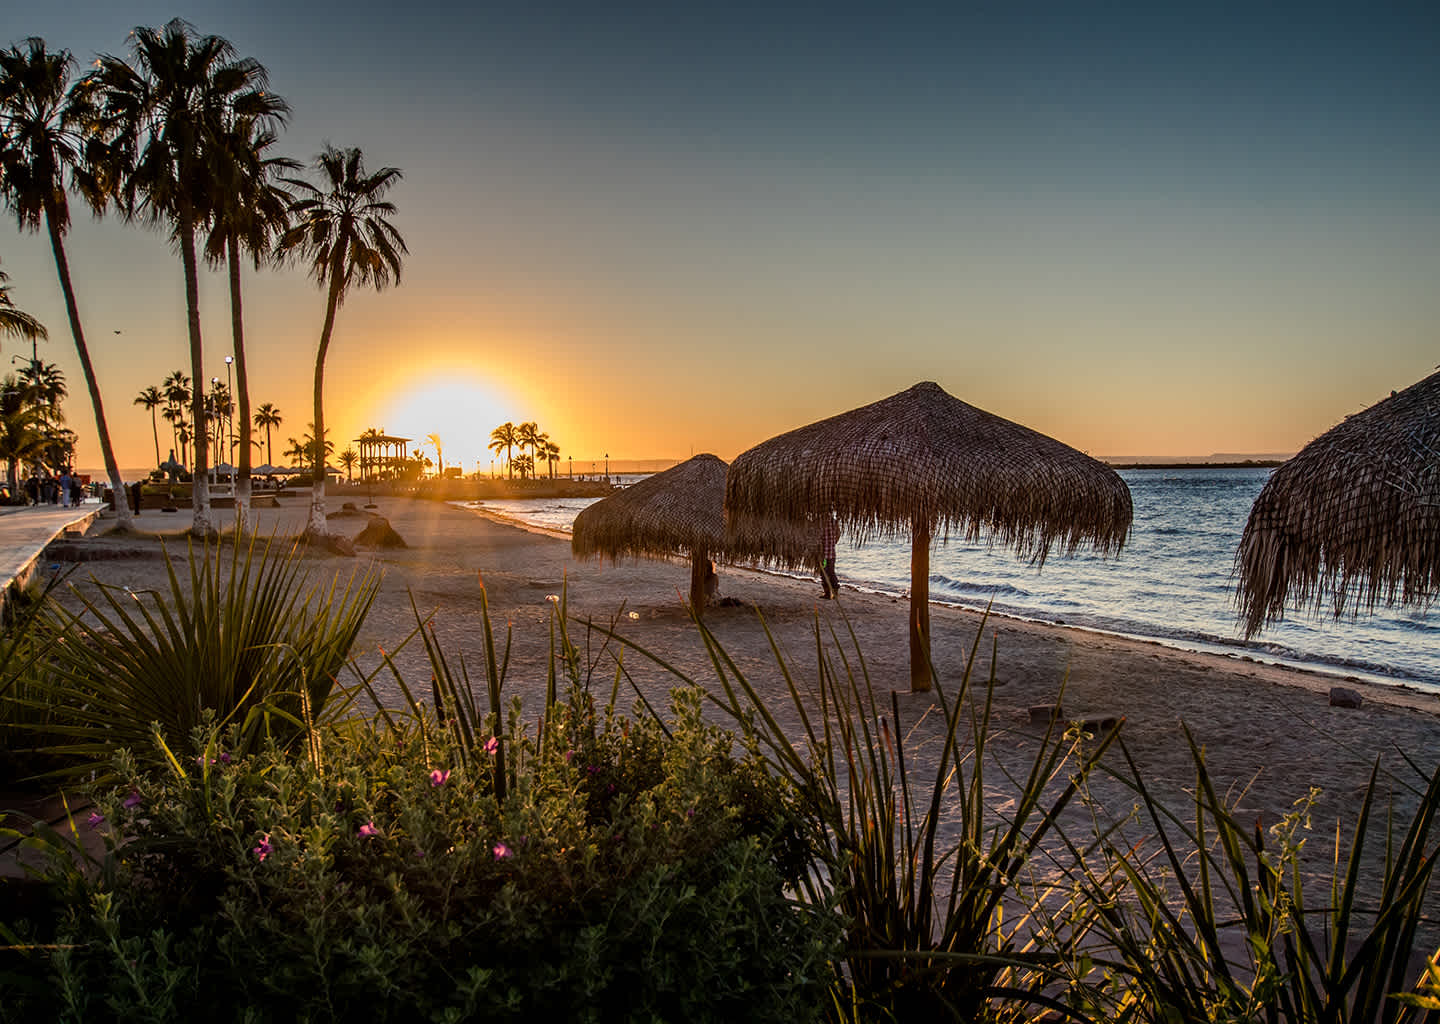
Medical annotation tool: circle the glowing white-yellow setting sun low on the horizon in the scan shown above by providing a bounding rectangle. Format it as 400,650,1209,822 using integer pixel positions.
373,373,516,474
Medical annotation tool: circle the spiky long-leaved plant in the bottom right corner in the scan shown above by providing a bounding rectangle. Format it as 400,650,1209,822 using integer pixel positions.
1086,730,1440,1024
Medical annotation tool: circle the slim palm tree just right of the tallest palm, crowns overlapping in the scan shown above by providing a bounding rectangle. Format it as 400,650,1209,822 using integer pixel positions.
204,107,300,533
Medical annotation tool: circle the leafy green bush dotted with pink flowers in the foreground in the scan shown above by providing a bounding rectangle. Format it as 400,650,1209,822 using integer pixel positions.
0,676,838,1021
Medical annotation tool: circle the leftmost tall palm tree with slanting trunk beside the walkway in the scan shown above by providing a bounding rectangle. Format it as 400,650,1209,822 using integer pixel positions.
0,37,134,531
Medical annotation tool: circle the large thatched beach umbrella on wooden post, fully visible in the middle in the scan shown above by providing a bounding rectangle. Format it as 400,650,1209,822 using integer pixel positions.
726,382,1132,690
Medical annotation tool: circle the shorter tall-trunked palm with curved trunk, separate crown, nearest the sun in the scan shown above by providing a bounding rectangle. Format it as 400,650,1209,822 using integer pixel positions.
279,145,406,536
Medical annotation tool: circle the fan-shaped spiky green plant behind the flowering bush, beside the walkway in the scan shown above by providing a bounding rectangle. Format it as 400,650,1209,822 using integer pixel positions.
8,539,379,771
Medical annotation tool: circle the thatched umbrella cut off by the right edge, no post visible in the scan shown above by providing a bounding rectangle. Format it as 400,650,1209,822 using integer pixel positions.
1236,373,1440,637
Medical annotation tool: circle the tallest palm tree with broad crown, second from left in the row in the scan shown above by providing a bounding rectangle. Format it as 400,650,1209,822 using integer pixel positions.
94,17,285,536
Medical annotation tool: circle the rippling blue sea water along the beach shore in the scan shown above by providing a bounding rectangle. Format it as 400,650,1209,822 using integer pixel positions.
457,468,1440,693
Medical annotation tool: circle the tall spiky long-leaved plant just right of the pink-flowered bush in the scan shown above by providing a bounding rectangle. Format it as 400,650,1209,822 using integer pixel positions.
602,604,1117,1021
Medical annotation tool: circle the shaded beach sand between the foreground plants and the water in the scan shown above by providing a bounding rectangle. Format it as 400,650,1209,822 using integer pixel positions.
43,495,1440,944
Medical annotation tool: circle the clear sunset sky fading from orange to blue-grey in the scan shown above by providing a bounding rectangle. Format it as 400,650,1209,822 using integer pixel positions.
0,0,1440,472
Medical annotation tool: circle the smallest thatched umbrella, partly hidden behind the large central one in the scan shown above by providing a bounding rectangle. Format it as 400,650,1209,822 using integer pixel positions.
570,455,727,614
